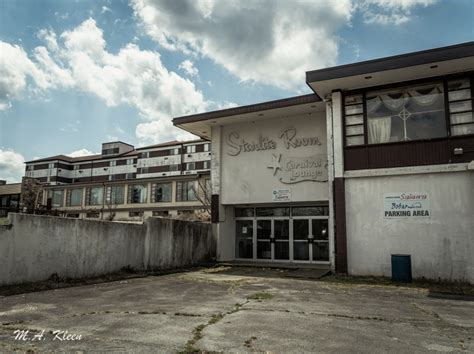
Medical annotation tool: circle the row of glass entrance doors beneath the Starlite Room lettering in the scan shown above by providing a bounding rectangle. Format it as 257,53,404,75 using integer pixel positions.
236,217,329,262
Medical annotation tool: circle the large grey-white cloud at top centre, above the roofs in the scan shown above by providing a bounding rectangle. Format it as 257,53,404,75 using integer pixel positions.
132,0,353,89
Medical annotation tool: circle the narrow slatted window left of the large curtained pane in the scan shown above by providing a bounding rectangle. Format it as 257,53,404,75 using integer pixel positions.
344,95,364,146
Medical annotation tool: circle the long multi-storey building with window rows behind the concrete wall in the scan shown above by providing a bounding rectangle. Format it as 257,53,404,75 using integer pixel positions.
26,140,211,220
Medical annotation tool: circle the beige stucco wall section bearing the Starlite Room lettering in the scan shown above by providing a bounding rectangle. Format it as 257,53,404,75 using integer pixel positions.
220,112,328,204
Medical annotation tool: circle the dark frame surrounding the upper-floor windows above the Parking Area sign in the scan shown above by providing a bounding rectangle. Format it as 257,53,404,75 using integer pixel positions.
341,71,474,149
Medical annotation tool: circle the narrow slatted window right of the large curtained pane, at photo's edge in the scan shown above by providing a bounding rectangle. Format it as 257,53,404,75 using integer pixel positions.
448,79,474,136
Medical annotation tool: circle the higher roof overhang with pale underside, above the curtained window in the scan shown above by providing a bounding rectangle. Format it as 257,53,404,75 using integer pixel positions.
306,42,474,97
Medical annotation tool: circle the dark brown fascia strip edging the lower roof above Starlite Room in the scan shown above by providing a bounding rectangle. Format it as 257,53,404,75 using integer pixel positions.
173,93,321,125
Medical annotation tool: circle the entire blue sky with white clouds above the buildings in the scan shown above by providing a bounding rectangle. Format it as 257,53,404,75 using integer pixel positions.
0,0,474,181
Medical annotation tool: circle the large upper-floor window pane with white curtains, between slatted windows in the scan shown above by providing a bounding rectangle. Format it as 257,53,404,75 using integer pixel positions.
366,82,447,144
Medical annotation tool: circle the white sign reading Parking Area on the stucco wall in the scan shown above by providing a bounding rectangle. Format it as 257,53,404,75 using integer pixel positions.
383,192,431,219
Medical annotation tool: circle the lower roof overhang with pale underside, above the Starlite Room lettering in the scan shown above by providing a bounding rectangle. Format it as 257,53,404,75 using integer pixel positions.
173,94,325,140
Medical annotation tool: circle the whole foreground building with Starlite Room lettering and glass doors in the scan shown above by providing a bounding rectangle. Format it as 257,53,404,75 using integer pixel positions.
173,42,474,282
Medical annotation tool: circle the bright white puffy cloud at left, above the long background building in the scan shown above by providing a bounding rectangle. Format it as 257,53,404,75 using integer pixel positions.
0,19,208,143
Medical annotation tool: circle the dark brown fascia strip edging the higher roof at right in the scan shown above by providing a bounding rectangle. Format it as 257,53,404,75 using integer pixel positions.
306,42,474,84
